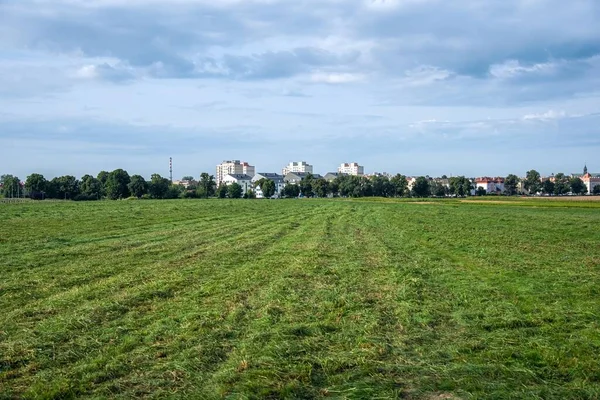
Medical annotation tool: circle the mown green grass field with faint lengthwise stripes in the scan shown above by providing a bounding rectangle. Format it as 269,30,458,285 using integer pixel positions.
0,199,600,399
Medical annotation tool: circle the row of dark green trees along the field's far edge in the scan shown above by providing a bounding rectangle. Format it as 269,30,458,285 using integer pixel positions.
0,169,600,201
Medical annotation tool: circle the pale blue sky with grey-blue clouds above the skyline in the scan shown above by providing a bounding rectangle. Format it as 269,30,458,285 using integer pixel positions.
0,0,600,179
